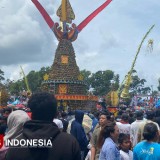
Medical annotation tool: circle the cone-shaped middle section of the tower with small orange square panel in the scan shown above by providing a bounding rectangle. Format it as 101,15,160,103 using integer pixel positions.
49,39,80,80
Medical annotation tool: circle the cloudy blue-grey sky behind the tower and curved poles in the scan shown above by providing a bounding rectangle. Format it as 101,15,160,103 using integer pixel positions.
0,0,160,89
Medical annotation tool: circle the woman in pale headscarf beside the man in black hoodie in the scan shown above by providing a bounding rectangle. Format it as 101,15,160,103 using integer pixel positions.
0,110,30,160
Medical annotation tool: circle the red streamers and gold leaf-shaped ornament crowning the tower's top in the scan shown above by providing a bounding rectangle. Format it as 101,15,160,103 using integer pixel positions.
32,0,112,42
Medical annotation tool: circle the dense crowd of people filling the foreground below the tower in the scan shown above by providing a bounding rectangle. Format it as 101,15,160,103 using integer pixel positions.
0,92,160,160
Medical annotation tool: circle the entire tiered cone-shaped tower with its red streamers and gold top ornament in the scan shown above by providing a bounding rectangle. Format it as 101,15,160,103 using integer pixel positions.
32,0,112,110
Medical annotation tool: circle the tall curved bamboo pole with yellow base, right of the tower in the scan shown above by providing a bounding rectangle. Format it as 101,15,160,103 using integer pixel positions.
120,25,155,99
